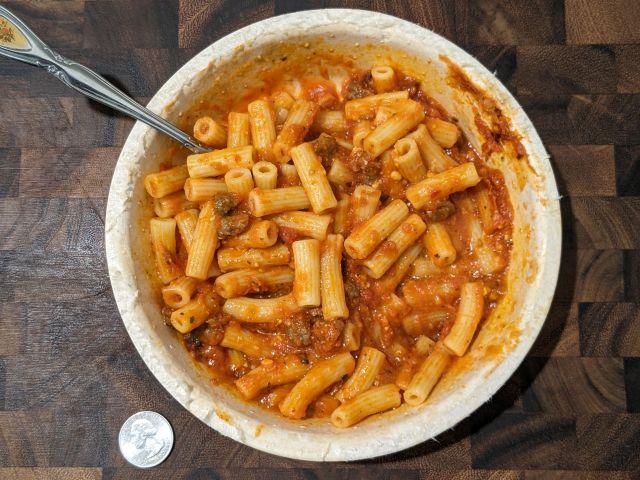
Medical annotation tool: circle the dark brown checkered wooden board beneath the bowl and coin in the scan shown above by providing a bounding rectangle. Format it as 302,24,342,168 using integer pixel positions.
0,0,640,480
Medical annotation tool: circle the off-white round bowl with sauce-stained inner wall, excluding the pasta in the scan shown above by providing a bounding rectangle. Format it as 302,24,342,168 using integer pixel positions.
105,10,561,461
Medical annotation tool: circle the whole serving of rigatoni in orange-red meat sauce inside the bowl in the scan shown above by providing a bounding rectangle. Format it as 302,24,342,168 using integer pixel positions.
144,58,520,428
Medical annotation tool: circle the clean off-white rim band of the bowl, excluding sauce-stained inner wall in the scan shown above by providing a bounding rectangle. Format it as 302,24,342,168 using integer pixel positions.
105,9,562,461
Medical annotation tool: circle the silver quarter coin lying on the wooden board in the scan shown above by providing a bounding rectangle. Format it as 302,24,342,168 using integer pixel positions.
118,411,173,468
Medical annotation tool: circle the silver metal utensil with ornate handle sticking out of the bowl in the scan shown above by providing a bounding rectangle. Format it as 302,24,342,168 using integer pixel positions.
0,5,209,153
